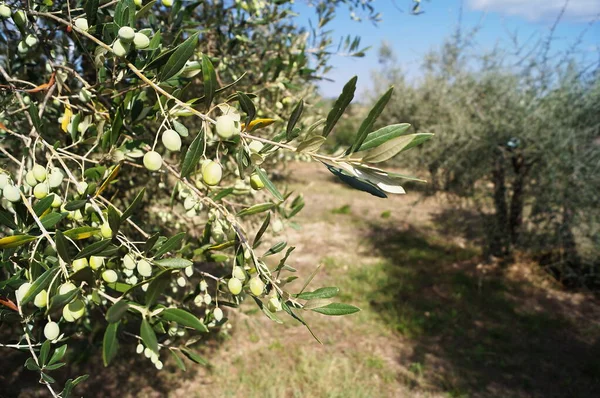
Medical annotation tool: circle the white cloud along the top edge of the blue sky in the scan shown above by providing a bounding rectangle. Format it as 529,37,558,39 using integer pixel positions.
469,0,600,21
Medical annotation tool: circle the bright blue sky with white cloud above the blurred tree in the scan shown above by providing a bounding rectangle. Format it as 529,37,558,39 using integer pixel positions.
295,0,600,97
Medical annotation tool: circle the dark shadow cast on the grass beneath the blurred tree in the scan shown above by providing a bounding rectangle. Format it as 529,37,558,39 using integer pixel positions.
355,224,600,397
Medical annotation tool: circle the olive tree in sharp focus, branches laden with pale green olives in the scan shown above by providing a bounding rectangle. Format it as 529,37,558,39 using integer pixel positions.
0,0,429,397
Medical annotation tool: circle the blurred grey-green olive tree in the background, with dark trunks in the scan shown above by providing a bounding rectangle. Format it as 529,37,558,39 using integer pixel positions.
378,31,600,284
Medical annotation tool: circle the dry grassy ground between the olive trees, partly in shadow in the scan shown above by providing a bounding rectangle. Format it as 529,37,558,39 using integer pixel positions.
0,163,600,398
